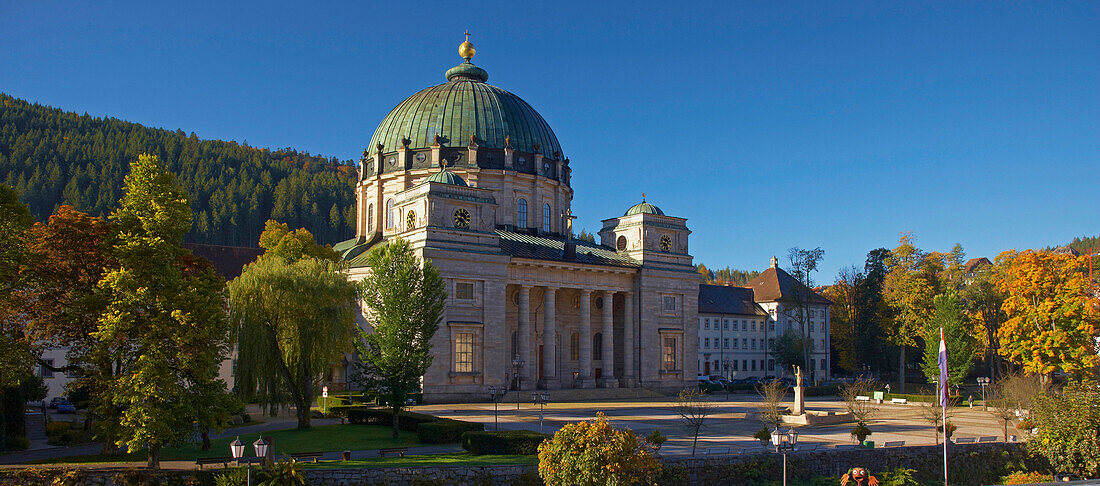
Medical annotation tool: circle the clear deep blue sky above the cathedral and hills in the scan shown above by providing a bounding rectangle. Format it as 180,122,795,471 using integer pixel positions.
0,1,1100,283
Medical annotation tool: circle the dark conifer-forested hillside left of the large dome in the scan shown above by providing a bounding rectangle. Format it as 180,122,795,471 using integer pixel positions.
0,93,356,246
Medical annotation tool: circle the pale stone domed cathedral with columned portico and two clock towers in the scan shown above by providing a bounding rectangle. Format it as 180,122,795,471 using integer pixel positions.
334,34,700,402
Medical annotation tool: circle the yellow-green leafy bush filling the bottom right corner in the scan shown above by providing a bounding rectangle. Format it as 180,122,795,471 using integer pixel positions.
1027,382,1100,477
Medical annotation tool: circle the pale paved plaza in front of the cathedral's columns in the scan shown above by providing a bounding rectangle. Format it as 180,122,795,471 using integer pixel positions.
414,393,1019,455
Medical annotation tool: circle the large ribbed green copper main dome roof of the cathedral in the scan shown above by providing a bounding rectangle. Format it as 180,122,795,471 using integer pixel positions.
367,62,562,158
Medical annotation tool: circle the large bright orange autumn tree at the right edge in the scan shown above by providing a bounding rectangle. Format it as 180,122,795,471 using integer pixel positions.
997,250,1100,382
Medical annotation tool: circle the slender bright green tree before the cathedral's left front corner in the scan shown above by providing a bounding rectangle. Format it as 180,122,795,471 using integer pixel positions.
355,239,447,439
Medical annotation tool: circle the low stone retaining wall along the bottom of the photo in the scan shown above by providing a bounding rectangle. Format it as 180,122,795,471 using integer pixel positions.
0,443,1025,486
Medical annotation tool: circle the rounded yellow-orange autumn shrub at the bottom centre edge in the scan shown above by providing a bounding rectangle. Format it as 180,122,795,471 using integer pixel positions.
539,412,661,486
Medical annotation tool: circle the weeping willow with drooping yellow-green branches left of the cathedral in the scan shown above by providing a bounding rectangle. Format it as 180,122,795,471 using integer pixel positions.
229,255,356,429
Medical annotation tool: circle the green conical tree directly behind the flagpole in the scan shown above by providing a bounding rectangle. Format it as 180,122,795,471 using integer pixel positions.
921,290,978,386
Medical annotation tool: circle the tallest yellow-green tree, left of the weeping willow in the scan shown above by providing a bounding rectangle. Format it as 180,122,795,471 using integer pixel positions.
96,154,229,468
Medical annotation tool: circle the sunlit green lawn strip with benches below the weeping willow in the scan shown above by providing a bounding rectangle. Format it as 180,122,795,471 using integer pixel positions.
30,424,420,464
